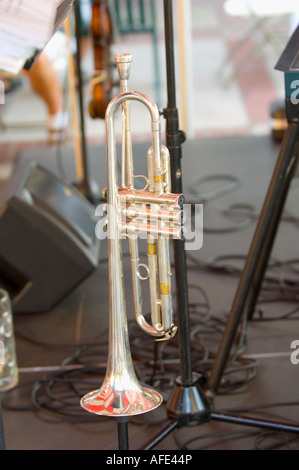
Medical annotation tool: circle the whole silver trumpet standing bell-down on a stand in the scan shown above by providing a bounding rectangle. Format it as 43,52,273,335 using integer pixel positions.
81,54,184,417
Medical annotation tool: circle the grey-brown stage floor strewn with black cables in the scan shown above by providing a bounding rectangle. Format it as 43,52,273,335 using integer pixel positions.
3,136,299,451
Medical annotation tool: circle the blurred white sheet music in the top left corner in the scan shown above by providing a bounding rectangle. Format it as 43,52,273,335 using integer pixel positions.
0,0,72,74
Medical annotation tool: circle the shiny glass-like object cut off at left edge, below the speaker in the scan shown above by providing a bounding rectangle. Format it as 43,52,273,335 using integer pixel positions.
0,289,19,393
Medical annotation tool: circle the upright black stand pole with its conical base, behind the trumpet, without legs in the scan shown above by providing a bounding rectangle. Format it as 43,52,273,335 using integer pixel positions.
163,0,208,424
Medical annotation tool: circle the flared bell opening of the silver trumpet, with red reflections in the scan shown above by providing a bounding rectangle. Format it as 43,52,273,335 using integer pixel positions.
81,382,163,417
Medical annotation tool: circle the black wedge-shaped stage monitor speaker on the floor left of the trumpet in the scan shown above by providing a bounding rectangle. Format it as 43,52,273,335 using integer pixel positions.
0,162,99,313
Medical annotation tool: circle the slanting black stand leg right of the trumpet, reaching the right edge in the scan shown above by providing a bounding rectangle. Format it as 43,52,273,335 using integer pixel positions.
207,123,299,399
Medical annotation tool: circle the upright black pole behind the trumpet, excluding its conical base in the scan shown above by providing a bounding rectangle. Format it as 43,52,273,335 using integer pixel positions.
164,0,193,386
